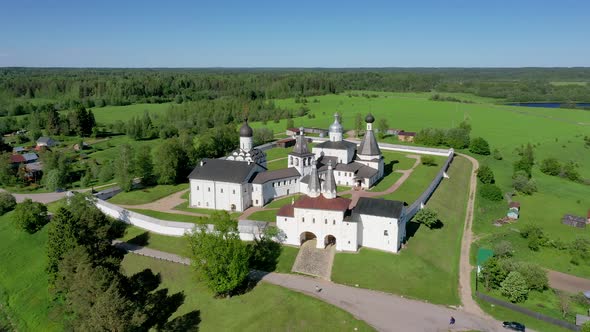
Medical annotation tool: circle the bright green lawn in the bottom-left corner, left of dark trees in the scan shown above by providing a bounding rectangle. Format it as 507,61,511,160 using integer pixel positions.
0,212,64,331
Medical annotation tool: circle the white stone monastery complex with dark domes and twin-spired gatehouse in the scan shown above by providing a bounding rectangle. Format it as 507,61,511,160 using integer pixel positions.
189,114,406,252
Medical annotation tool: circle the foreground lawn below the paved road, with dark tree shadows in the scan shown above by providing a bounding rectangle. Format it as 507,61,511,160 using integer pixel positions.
123,254,372,331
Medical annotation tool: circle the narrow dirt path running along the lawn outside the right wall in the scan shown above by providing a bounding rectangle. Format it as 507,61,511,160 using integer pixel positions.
457,153,489,318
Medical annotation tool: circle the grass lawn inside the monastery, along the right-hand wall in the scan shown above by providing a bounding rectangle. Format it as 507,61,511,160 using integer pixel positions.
375,156,446,204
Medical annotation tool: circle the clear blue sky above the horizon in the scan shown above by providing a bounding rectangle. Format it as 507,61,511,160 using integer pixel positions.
0,0,590,67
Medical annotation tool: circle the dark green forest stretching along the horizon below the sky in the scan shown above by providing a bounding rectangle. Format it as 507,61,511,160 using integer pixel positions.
0,68,590,115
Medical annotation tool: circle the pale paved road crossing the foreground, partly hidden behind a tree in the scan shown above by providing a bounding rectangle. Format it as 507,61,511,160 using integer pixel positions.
114,241,502,331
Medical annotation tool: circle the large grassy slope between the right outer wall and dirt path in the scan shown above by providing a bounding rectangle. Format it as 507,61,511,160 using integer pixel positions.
332,157,471,304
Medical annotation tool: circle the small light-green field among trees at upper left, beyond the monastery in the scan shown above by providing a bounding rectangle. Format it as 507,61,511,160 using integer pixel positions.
92,103,170,124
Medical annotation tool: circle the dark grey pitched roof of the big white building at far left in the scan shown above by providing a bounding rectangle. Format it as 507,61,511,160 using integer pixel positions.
188,158,257,183
